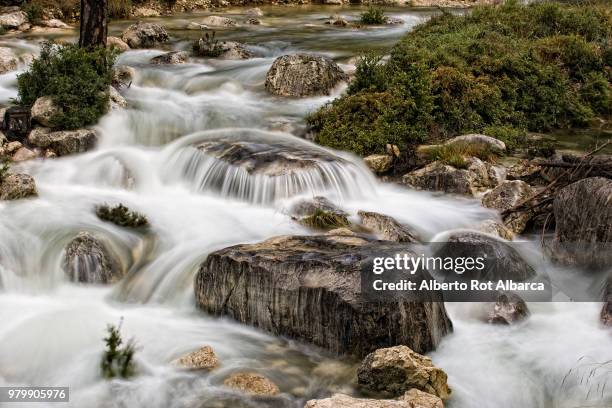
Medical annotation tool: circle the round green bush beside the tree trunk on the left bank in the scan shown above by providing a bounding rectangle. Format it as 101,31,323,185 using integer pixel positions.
17,43,116,129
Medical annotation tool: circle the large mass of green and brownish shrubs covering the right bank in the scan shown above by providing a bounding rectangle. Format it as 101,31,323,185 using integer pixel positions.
307,2,612,155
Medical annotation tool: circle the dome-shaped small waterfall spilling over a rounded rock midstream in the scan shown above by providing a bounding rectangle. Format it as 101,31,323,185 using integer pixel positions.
161,129,375,204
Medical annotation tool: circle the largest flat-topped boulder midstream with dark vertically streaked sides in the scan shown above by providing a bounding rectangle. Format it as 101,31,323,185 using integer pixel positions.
194,235,452,356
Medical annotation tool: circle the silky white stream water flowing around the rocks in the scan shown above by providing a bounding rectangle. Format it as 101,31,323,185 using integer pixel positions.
0,6,612,408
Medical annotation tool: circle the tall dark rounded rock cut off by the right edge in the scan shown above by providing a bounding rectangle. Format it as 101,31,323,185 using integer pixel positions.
553,177,612,269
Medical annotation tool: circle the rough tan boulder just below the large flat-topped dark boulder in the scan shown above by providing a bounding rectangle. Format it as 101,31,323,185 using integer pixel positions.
357,346,451,399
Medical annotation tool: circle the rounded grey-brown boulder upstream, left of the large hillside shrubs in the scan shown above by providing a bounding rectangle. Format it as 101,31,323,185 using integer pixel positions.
266,54,347,97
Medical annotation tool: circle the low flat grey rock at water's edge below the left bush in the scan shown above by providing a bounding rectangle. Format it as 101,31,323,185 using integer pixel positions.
28,128,98,156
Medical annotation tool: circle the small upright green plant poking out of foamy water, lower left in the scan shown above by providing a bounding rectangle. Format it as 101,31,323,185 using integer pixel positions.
101,323,136,379
